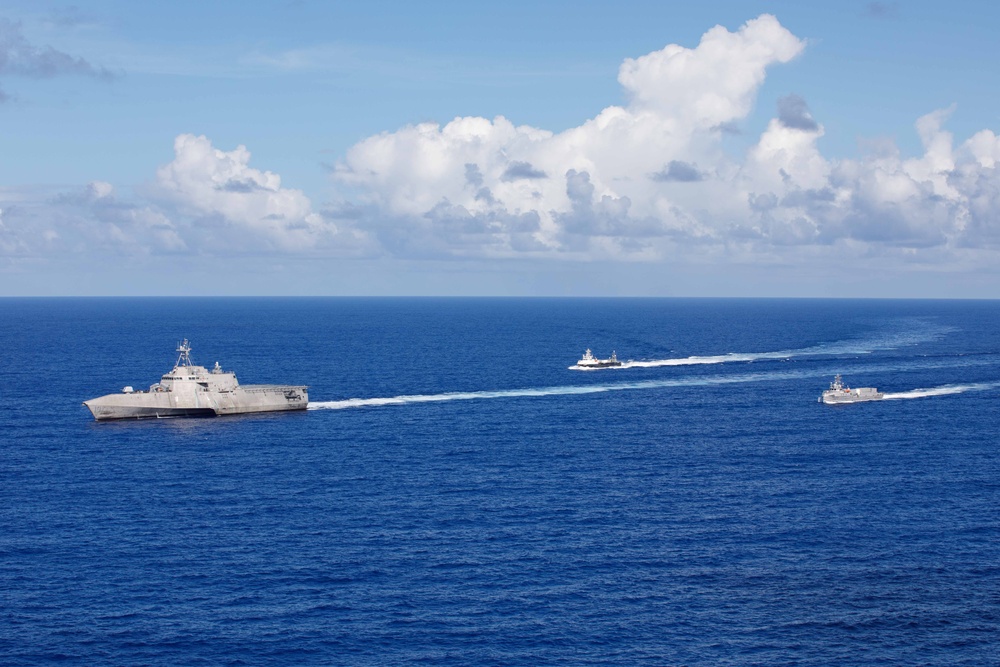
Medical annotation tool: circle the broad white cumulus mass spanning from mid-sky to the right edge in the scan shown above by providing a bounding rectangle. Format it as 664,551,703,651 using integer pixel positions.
333,14,1000,259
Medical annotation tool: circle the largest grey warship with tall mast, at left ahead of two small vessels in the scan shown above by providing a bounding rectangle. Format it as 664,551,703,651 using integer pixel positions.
83,338,309,421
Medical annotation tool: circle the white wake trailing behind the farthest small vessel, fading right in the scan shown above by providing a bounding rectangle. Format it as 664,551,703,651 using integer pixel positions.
569,326,954,371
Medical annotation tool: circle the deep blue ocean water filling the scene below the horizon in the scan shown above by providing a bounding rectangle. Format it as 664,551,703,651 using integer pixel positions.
0,298,1000,665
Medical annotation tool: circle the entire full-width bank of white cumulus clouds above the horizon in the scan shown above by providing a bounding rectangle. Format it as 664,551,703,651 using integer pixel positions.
0,15,1000,276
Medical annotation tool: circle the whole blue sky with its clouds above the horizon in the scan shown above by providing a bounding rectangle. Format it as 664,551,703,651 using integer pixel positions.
0,0,1000,298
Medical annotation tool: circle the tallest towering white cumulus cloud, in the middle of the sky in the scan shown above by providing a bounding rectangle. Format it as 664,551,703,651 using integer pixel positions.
334,15,804,257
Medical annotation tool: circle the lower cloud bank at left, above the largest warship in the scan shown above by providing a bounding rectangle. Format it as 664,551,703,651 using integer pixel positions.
0,134,371,257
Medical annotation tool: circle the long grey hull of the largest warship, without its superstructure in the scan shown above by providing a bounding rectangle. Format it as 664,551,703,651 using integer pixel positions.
84,385,309,421
